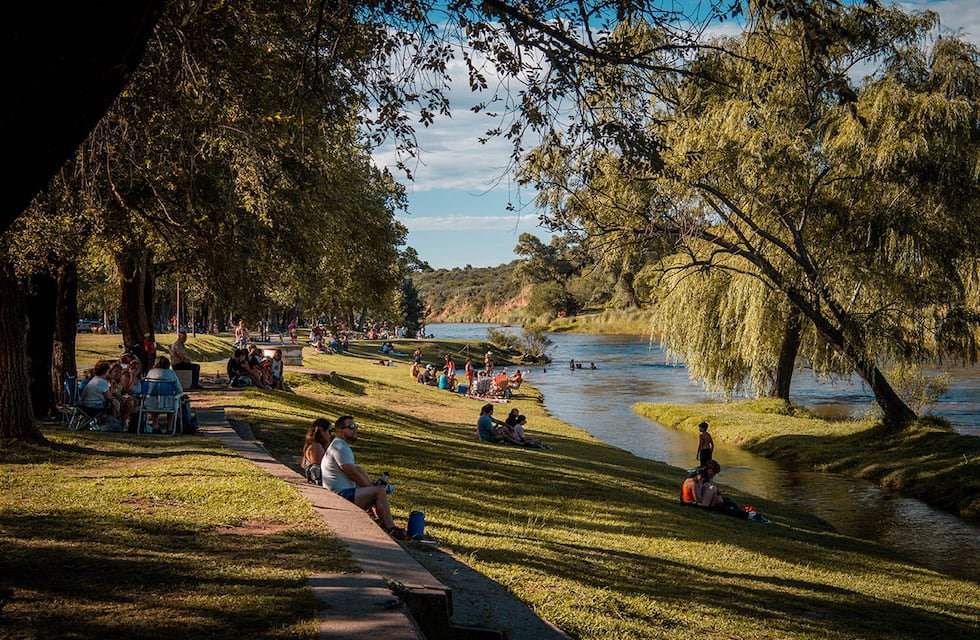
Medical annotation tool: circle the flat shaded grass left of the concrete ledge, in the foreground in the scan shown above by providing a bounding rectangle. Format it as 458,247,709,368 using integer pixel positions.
0,429,356,640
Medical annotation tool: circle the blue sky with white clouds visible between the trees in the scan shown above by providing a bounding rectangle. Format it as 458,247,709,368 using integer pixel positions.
374,0,980,269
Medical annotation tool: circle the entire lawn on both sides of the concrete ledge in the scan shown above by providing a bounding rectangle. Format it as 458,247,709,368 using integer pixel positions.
0,340,980,640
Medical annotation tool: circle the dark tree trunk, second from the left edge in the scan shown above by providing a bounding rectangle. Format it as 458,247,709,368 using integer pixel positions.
26,274,58,417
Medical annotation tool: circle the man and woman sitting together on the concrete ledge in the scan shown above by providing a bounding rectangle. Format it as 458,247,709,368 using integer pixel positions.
303,416,410,540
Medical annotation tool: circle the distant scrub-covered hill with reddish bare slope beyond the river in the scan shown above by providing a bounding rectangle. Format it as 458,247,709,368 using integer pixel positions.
412,260,530,322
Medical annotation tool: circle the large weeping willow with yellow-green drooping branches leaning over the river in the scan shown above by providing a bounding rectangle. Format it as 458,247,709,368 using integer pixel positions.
526,2,980,425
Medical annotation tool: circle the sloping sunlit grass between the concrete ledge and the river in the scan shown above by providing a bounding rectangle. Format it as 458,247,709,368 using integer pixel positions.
222,349,980,639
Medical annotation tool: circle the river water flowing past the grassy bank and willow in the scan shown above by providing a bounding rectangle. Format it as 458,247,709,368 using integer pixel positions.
427,323,980,579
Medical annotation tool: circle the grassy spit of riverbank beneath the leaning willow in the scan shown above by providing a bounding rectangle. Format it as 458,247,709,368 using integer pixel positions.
633,400,980,522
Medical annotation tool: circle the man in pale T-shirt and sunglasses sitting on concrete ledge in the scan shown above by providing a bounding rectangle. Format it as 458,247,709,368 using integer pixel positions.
320,416,409,540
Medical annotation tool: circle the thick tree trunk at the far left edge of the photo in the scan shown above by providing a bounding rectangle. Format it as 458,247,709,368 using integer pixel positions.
0,262,47,443
